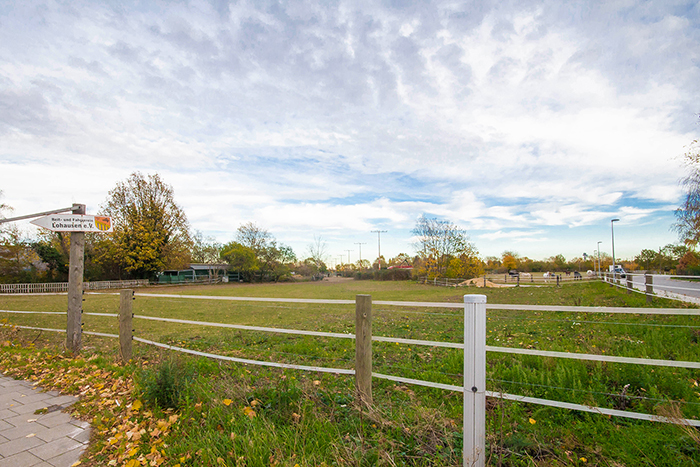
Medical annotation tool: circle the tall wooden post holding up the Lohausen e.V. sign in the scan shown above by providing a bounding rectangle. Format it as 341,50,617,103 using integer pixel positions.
66,204,85,355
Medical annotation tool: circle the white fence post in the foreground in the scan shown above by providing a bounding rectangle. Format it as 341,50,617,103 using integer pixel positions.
462,295,486,467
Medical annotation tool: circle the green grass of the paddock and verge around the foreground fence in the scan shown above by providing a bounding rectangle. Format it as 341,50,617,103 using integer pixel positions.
0,281,700,466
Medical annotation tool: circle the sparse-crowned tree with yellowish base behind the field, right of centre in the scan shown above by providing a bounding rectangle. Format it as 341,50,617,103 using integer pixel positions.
413,215,479,279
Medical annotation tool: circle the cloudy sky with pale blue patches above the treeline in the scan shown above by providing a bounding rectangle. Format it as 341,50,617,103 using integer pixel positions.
0,0,700,263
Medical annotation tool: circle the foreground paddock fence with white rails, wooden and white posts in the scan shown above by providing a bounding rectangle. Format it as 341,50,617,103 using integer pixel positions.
0,290,700,465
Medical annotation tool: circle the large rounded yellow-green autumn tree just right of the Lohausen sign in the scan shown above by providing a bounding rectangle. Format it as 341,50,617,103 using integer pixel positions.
97,172,192,278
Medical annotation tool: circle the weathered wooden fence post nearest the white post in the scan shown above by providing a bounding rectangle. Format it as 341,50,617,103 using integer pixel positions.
355,295,372,406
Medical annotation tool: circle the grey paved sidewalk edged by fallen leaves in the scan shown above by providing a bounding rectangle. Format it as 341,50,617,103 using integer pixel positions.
0,375,90,467
